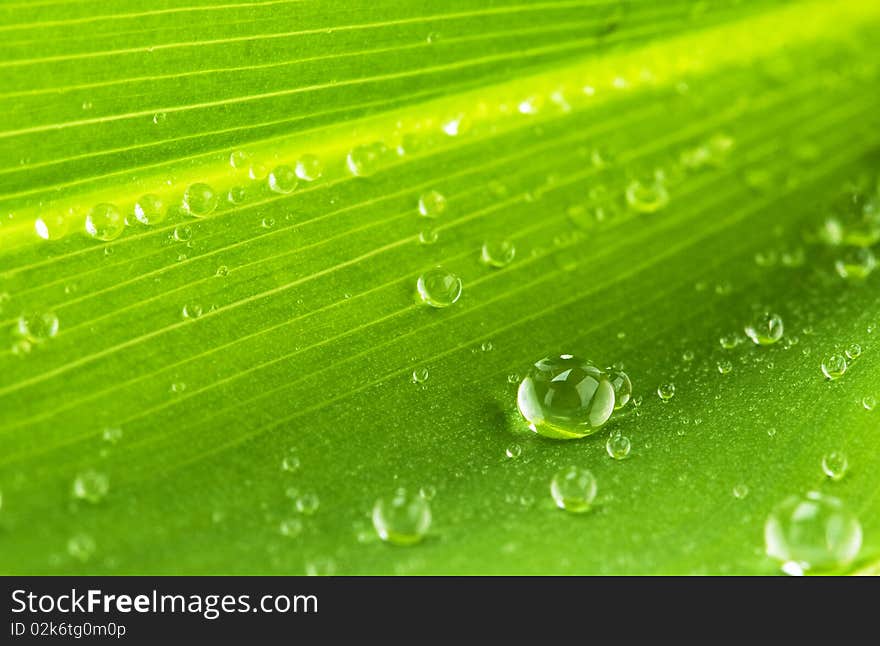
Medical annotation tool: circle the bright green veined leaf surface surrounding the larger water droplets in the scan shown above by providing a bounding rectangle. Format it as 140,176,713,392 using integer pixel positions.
0,0,880,574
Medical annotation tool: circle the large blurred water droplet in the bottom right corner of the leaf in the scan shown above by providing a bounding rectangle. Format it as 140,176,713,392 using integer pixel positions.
764,491,862,573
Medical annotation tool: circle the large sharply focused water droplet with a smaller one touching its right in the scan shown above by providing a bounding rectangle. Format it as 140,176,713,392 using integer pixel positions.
517,354,614,439
